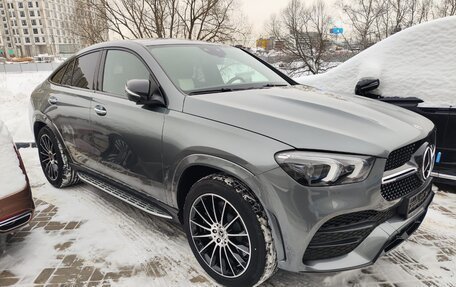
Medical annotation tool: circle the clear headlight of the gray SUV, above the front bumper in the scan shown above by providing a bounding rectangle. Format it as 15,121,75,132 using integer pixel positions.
275,151,375,186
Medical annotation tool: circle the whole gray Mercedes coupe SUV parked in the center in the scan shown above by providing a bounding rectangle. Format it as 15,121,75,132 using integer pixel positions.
31,40,435,286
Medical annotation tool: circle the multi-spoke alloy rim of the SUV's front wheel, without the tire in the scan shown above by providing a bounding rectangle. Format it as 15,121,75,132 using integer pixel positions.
189,193,251,278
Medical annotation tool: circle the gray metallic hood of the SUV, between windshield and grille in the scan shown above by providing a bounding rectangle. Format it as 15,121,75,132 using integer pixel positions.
184,86,434,157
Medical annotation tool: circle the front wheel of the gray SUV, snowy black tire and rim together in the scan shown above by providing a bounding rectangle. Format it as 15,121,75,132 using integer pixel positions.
184,174,277,286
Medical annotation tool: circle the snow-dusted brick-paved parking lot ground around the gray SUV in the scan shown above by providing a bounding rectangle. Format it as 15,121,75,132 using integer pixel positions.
0,149,456,287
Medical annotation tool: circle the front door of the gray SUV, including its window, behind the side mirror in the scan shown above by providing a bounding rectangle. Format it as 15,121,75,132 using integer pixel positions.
90,49,167,201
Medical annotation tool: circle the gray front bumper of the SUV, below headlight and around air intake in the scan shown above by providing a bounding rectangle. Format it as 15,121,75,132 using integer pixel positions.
258,159,433,272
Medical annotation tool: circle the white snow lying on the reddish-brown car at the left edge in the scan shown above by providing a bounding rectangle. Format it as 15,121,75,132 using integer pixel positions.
0,121,27,199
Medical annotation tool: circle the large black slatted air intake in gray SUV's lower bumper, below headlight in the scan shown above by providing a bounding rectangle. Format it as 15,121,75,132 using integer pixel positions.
303,207,396,262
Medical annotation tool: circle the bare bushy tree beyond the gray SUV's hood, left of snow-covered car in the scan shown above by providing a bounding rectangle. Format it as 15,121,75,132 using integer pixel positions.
269,0,331,74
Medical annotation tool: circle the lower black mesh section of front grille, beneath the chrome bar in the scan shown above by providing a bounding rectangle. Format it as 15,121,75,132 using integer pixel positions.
381,173,423,201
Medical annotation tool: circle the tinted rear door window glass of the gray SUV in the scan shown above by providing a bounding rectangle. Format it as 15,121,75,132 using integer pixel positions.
71,52,100,89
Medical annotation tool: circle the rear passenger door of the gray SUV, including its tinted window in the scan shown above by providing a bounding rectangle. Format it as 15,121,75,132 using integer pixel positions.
46,51,101,171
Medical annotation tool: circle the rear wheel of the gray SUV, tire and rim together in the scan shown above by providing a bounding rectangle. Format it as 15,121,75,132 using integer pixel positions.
36,127,79,188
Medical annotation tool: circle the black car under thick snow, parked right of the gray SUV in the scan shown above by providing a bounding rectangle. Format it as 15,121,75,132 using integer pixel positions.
295,16,456,185
